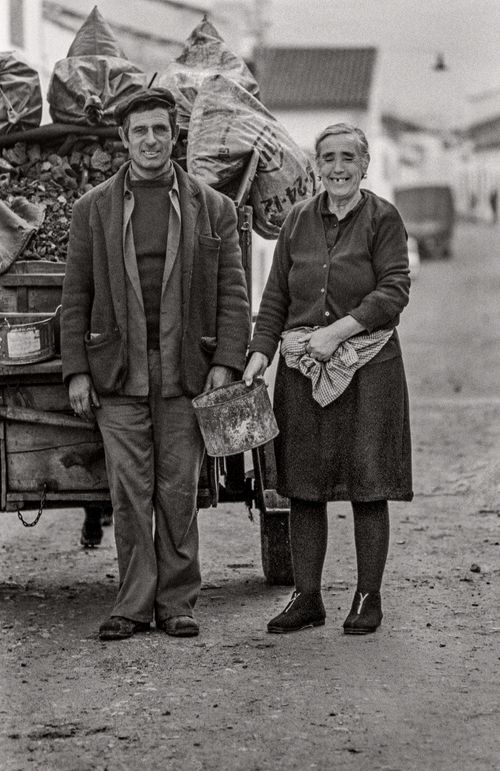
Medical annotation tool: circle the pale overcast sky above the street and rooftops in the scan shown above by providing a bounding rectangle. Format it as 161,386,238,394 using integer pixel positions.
262,0,500,128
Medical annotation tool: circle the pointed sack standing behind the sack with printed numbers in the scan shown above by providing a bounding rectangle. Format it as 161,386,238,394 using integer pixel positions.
158,17,259,129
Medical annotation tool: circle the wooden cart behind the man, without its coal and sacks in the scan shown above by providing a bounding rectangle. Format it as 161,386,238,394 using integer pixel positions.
0,126,293,585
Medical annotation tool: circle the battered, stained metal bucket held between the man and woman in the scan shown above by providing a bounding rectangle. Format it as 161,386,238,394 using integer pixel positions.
192,378,278,458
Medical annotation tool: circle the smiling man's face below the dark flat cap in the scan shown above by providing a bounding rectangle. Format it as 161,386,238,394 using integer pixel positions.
119,107,178,179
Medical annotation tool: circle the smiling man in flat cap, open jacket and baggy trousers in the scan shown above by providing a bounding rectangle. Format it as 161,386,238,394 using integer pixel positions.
61,88,250,640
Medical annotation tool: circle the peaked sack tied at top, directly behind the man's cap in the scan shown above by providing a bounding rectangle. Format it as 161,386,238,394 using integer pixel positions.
47,7,147,126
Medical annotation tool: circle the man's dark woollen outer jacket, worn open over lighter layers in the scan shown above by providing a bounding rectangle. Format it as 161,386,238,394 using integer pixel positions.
61,164,250,397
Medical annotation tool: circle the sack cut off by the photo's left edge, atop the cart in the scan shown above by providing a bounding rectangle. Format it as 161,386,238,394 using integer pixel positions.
0,51,42,134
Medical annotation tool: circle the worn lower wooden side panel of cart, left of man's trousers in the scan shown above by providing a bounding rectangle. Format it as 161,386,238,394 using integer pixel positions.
0,362,109,511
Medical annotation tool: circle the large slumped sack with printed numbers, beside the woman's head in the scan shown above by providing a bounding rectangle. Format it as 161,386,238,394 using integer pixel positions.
187,75,316,238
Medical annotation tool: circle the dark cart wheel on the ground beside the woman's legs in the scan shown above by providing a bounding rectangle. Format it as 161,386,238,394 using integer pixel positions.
260,510,294,586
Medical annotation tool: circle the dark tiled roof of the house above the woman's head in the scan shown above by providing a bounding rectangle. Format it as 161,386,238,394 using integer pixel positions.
254,48,377,109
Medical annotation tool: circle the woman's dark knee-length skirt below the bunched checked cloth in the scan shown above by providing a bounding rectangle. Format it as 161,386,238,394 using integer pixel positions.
274,356,413,501
